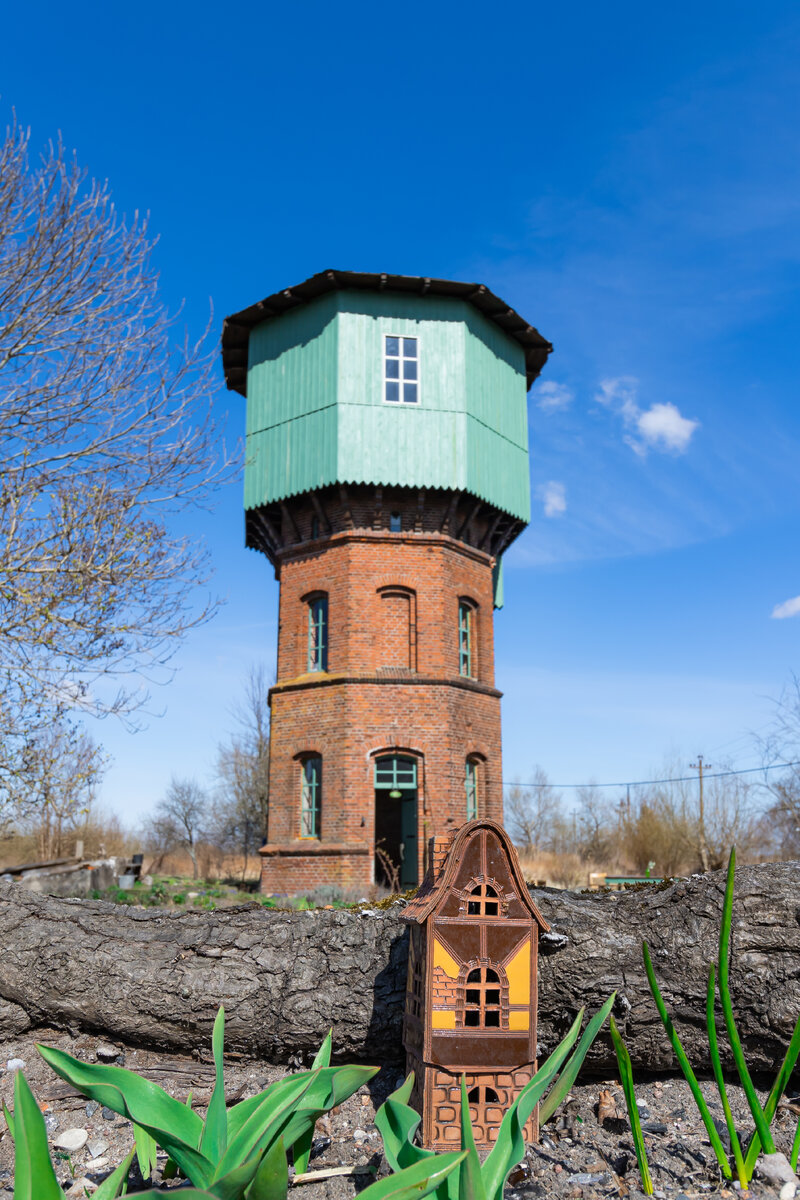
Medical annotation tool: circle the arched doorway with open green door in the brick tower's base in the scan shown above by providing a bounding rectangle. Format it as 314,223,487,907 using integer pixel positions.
375,755,419,888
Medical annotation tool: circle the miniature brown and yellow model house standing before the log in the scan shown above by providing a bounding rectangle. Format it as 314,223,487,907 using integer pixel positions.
403,820,549,1150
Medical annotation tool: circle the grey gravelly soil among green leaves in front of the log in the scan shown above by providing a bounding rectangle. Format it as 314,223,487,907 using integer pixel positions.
0,1030,796,1200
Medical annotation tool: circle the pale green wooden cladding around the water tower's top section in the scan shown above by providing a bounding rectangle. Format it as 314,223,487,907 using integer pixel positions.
245,292,530,521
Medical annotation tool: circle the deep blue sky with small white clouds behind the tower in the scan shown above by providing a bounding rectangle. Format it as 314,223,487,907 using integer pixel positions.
0,0,800,821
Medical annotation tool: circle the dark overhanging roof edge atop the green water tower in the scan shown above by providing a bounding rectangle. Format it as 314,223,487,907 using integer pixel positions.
222,271,553,396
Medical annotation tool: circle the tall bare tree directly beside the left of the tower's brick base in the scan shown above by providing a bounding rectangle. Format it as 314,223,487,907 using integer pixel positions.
212,665,270,878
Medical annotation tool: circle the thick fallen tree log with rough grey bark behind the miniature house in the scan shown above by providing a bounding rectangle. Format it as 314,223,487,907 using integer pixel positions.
0,863,800,1070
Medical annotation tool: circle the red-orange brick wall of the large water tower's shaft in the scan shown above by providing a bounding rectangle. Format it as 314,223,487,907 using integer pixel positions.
261,530,503,890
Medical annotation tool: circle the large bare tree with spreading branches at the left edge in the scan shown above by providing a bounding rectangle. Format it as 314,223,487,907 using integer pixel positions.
0,125,229,769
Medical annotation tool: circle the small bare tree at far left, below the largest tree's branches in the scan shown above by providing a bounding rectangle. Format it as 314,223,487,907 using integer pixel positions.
8,722,108,859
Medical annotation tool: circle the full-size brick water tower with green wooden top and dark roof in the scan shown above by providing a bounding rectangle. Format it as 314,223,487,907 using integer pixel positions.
223,271,551,893
